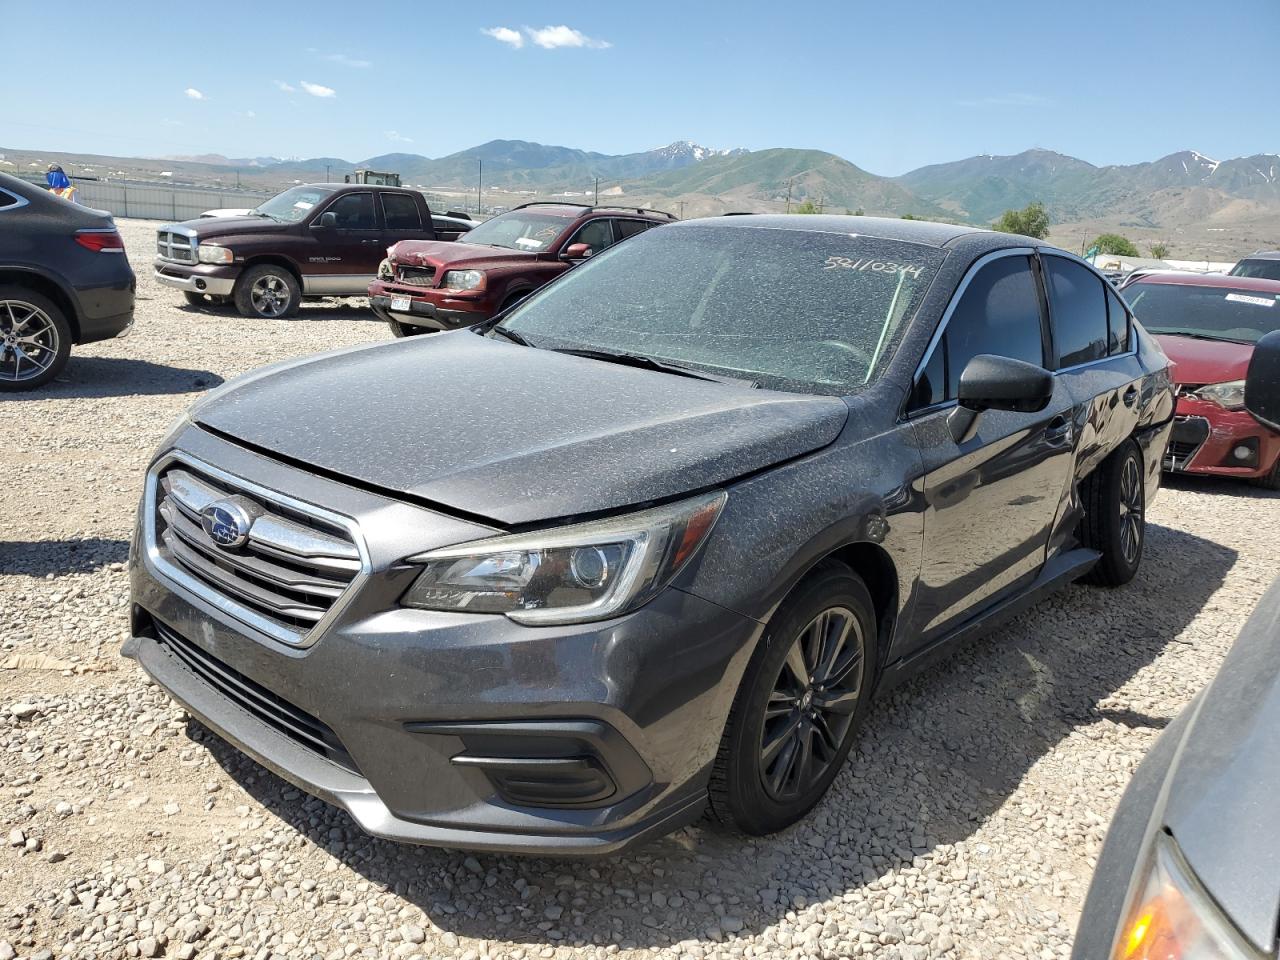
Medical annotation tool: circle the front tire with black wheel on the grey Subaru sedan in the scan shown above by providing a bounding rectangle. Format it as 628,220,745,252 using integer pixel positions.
709,561,878,836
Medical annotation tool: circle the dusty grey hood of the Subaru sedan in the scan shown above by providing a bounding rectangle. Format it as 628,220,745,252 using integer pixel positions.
192,330,849,526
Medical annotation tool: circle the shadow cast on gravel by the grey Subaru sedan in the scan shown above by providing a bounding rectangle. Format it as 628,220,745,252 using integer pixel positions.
188,525,1236,952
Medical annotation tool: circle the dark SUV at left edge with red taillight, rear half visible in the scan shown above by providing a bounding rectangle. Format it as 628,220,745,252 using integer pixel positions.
0,174,136,392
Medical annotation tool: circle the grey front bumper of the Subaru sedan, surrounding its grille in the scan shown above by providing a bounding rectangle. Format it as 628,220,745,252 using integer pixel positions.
123,429,759,854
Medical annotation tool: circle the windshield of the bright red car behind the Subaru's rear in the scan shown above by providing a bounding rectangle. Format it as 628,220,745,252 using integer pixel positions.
1124,280,1280,343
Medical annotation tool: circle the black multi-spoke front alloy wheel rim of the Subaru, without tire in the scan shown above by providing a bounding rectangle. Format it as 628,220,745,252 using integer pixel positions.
759,607,865,801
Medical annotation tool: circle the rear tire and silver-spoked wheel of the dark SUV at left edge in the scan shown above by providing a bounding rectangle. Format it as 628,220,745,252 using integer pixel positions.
0,285,72,393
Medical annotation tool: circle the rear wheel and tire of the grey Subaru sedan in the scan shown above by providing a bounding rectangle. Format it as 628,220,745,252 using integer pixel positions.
1080,440,1147,586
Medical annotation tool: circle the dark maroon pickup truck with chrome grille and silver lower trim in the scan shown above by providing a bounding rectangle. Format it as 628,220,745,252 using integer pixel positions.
155,183,471,319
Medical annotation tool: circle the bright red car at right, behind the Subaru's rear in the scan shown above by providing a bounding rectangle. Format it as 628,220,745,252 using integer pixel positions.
1123,274,1280,490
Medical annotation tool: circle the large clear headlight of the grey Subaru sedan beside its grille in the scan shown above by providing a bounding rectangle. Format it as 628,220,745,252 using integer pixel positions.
402,493,728,623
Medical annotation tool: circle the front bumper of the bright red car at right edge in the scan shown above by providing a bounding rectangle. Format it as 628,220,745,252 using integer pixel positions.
1164,396,1280,480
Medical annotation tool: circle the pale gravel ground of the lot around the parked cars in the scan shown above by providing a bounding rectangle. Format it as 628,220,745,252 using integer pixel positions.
0,221,1280,960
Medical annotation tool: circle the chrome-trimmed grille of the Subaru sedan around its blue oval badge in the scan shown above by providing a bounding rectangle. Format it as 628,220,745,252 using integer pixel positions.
148,462,362,644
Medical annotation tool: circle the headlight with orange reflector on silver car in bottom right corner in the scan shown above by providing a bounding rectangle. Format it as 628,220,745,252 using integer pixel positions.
1111,833,1262,960
